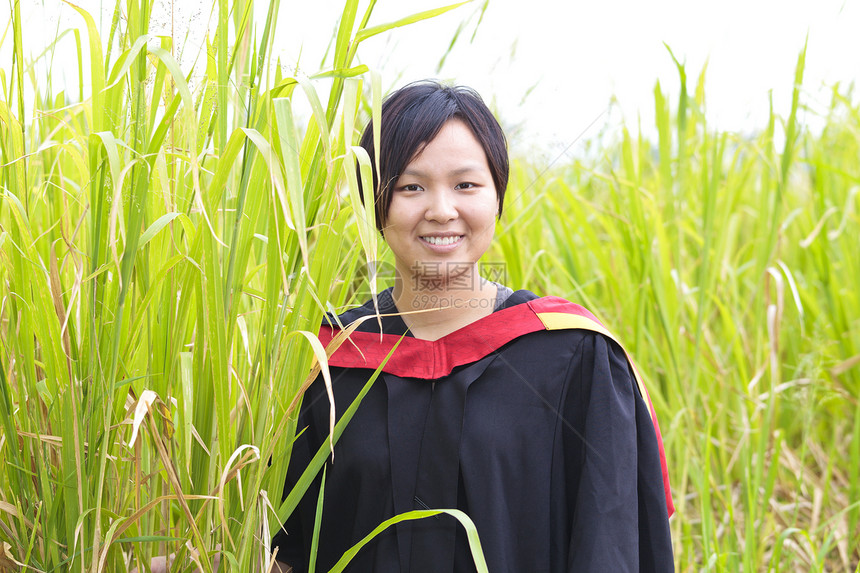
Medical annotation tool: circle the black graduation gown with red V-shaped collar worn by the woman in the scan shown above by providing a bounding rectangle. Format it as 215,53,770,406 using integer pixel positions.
273,291,674,573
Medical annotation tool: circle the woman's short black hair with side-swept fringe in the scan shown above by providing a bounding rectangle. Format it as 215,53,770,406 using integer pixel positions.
358,80,510,230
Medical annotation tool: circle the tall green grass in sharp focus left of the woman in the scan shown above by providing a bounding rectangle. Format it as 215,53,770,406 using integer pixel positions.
0,0,470,572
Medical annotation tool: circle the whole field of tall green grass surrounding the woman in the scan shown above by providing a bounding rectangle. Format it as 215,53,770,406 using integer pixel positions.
0,0,860,572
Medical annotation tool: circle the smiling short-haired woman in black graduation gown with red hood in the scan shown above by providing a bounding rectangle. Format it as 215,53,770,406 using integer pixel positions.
273,82,673,573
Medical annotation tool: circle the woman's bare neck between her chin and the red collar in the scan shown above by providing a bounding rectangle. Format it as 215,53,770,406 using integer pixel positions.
393,265,497,340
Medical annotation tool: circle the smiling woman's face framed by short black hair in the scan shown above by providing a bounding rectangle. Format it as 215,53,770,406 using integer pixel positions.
385,119,499,289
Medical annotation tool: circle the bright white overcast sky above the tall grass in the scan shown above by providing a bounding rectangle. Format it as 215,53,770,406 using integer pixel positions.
0,0,860,155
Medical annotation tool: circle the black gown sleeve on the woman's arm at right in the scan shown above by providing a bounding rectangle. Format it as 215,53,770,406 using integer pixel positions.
566,334,674,573
